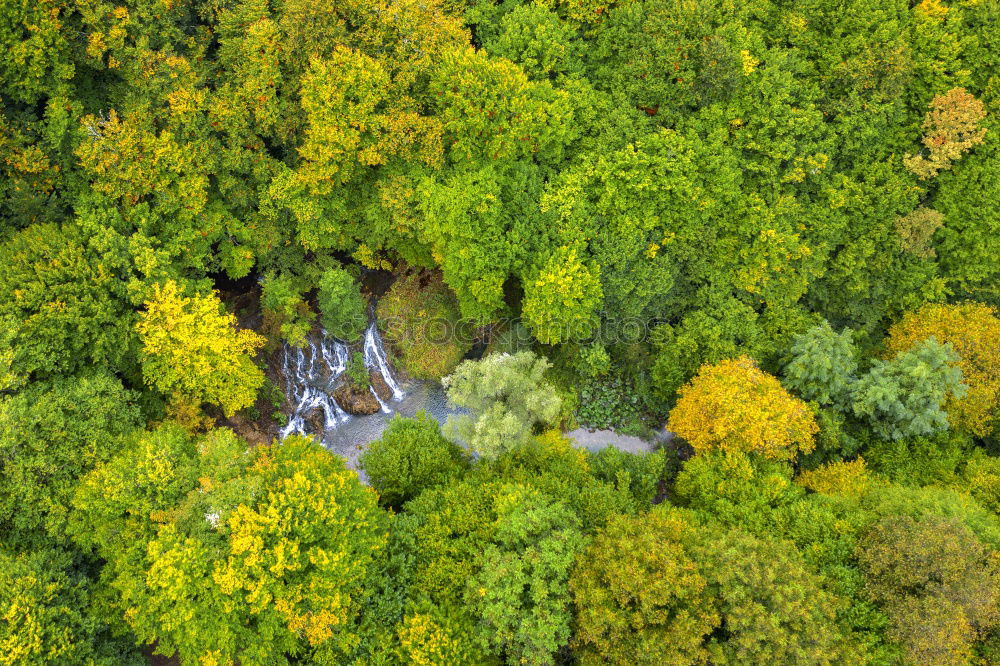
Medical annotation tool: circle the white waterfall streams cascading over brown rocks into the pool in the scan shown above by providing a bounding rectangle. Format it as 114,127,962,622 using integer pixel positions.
279,316,404,439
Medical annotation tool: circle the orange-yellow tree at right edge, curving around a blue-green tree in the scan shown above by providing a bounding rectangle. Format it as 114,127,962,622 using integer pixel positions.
886,303,1000,437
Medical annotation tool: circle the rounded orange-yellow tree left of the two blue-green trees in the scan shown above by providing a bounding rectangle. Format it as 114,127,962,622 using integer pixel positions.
667,356,819,460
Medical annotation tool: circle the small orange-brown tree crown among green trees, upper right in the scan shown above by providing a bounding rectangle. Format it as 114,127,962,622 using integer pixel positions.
903,88,986,179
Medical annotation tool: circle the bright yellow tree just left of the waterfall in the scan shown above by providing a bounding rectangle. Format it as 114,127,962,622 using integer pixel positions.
136,280,264,415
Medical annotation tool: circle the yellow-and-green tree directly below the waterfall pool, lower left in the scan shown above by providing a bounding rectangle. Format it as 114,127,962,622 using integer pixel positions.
212,438,386,647
